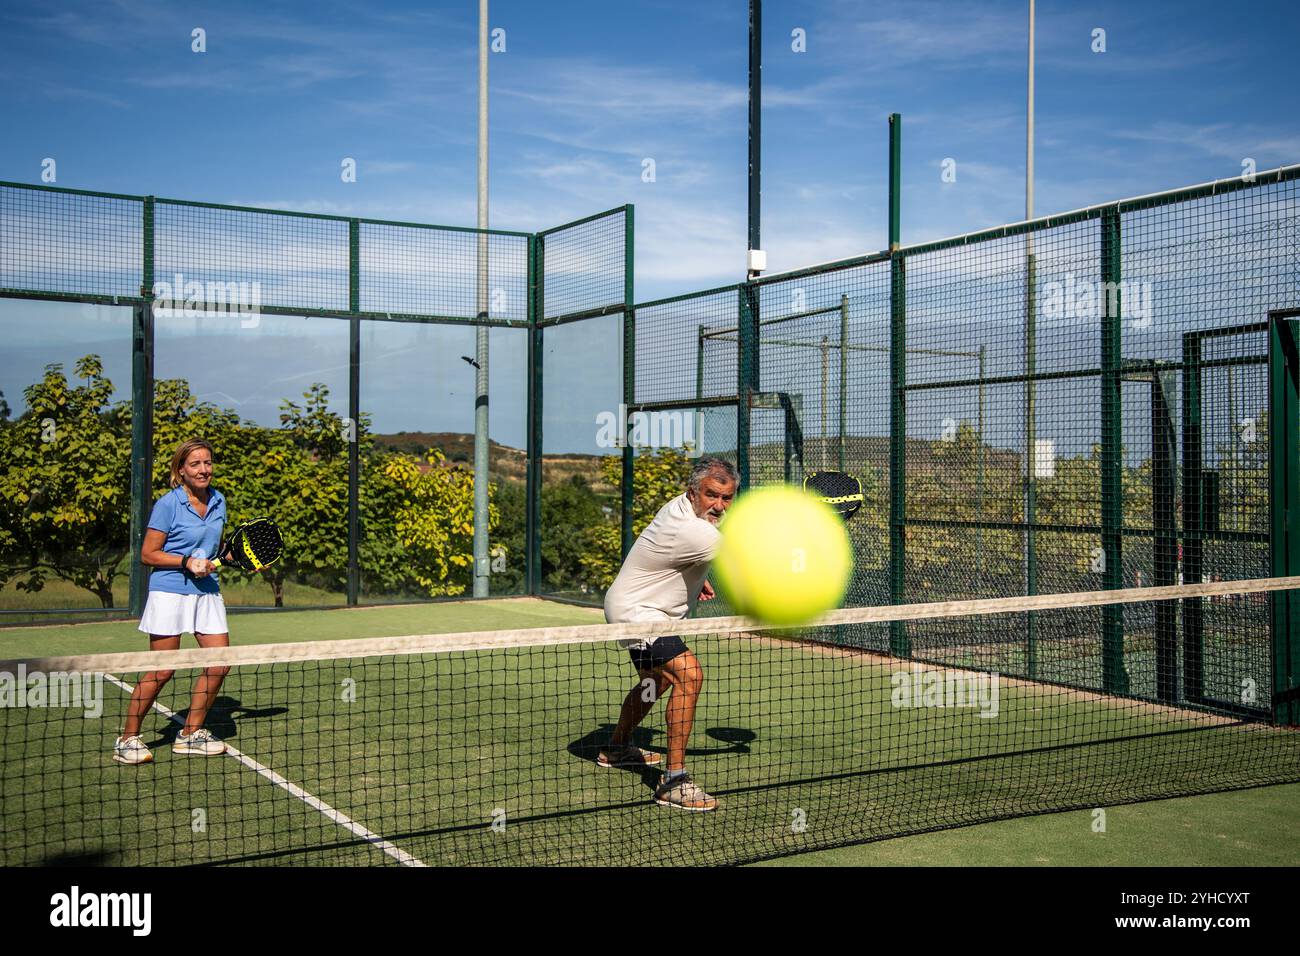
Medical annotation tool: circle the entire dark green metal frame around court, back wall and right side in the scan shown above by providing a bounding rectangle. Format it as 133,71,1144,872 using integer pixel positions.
0,158,1300,723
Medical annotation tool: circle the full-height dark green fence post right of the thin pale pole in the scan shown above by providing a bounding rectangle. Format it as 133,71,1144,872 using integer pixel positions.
1101,206,1128,695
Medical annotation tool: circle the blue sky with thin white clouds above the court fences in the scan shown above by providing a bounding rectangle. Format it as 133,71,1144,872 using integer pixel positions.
0,0,1300,450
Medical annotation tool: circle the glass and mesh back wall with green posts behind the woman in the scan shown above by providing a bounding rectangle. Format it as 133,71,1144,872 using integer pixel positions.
0,183,632,622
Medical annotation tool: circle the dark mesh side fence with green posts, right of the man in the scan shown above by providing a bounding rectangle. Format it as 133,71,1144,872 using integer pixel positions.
632,166,1300,717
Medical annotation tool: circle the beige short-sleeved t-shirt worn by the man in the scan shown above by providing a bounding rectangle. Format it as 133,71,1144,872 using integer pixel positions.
605,494,722,646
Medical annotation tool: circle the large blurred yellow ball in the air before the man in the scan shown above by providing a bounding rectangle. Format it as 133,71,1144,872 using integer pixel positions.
712,485,853,626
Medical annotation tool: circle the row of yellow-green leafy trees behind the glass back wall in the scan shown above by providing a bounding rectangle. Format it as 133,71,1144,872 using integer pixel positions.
0,355,499,607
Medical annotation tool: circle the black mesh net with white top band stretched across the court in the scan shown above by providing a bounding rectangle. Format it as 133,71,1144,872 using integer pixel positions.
0,578,1300,866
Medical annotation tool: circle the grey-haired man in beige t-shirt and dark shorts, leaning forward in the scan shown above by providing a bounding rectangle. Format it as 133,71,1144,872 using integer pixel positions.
597,458,740,812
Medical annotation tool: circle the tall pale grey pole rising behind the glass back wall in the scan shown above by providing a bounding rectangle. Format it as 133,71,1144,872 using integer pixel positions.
475,0,491,597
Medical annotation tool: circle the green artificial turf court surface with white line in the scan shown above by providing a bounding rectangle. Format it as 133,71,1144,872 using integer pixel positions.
0,600,1300,865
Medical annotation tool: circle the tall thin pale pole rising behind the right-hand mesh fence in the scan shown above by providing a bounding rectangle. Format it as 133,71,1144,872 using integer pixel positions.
1024,0,1039,678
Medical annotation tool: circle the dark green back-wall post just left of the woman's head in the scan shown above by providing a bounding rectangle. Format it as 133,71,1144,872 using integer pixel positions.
127,196,155,617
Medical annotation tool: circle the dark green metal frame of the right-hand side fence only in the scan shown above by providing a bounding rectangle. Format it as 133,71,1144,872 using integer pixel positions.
629,153,1300,722
